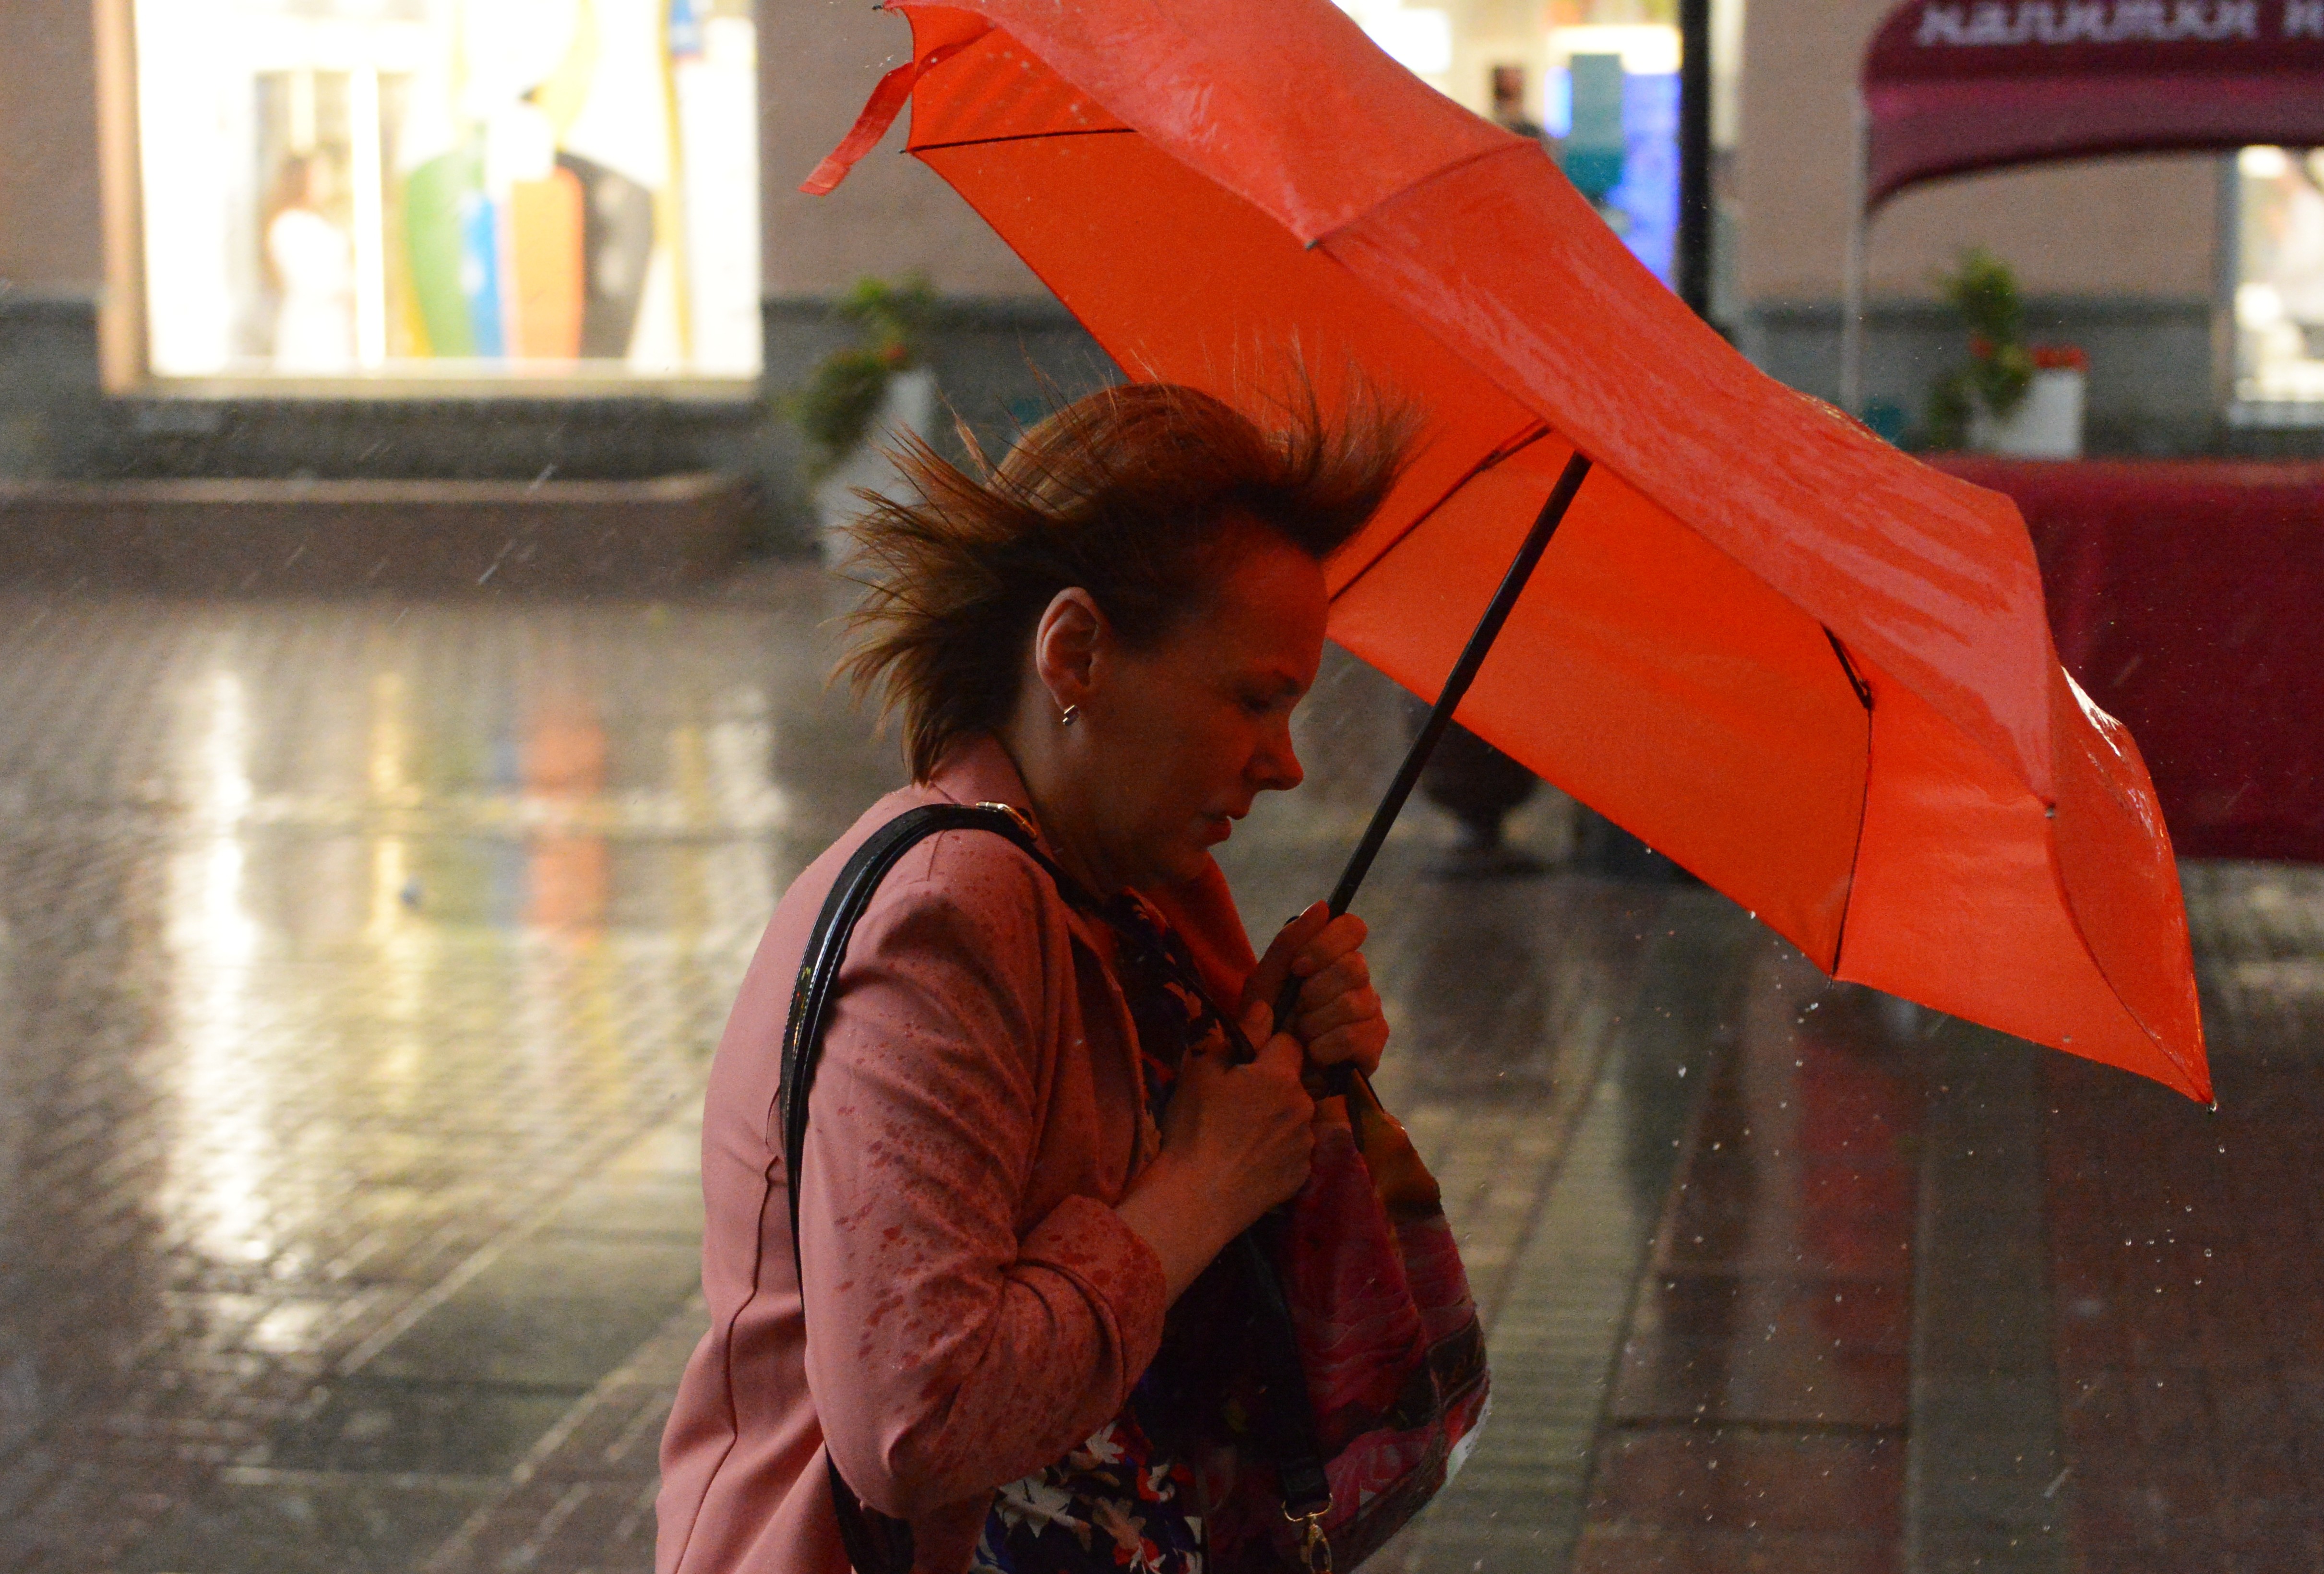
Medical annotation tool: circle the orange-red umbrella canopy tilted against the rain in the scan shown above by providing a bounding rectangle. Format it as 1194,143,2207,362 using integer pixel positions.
809,0,2210,1097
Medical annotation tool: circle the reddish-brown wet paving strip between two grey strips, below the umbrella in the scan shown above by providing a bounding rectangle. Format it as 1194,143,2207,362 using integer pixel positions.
1573,942,1919,1574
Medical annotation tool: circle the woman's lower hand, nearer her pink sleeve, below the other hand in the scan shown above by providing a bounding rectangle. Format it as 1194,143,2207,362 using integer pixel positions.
1116,1002,1315,1300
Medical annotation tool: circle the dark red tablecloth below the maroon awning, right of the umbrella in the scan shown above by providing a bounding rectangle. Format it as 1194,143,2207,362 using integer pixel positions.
1936,456,2324,862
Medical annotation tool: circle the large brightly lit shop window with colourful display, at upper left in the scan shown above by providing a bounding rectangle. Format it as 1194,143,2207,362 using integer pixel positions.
135,0,760,383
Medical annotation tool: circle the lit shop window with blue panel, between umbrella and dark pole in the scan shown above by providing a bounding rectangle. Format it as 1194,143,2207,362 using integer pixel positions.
1339,0,1678,284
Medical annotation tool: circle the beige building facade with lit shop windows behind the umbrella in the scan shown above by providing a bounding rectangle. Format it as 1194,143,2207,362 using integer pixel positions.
0,0,2324,558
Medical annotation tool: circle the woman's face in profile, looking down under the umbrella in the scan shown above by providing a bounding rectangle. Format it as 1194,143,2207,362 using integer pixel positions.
1076,528,1327,886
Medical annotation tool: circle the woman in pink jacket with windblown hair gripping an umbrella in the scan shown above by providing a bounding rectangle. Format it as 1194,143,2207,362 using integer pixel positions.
658,386,1401,1574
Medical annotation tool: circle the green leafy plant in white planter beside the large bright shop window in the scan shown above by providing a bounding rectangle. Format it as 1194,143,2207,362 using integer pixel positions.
790,274,937,560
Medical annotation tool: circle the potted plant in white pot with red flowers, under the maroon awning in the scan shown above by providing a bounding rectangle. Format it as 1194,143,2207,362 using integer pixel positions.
1929,247,2089,458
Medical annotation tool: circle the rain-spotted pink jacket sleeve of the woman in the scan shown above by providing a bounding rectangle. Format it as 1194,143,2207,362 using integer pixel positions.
786,835,1167,1518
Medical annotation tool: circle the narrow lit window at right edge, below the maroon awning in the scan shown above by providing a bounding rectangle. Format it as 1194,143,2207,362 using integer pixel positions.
2236,146,2324,421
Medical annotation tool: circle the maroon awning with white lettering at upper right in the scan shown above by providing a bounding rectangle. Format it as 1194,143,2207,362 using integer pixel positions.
1864,0,2324,209
